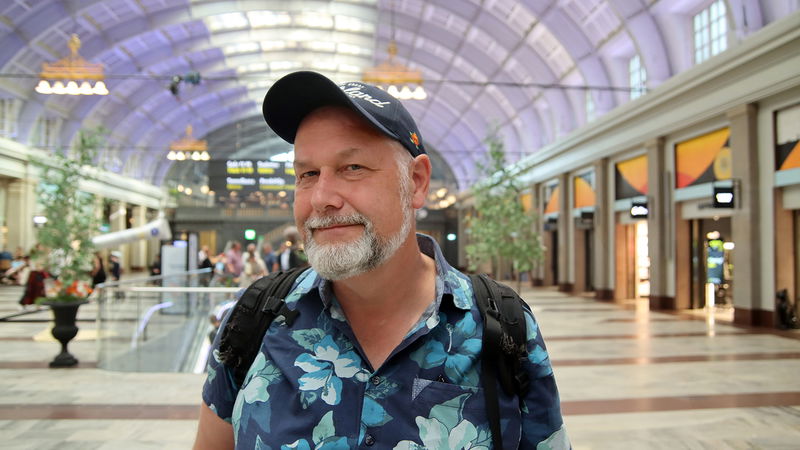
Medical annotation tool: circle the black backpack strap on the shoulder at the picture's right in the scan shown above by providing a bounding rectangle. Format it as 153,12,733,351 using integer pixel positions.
469,275,528,450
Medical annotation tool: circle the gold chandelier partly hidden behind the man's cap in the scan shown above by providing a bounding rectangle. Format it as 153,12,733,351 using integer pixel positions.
362,39,428,100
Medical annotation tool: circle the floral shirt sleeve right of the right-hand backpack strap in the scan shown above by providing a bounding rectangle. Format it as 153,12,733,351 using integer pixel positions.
521,309,571,450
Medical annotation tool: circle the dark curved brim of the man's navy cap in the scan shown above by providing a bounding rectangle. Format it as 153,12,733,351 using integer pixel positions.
262,71,398,144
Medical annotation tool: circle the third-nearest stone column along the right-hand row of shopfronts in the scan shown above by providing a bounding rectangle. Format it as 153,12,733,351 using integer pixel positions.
592,158,614,301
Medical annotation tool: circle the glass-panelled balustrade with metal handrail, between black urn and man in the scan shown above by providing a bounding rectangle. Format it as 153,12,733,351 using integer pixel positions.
97,269,239,373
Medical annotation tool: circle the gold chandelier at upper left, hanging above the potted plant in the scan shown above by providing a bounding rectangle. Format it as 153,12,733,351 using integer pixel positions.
35,34,108,95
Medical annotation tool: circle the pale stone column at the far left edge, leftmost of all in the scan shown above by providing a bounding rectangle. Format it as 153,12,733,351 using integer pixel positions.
6,179,35,254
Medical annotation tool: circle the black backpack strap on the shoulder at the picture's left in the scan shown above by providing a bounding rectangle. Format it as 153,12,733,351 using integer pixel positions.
219,268,304,387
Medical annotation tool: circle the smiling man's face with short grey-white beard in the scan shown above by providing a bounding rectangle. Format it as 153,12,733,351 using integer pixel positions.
294,108,414,280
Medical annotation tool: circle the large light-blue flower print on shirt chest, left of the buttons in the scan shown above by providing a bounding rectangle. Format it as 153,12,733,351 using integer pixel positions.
294,336,369,406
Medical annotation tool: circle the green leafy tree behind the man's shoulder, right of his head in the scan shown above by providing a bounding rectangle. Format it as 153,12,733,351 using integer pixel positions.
466,130,543,290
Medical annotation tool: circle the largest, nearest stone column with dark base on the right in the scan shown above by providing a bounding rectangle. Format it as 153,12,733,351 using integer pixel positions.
728,103,774,327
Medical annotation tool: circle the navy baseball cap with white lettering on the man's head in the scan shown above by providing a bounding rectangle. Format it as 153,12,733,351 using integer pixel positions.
262,71,425,157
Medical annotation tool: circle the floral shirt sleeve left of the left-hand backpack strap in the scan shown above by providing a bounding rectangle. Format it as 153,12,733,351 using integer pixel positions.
203,308,239,422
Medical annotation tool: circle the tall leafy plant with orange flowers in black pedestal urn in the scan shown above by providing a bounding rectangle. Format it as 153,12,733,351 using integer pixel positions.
32,129,103,367
